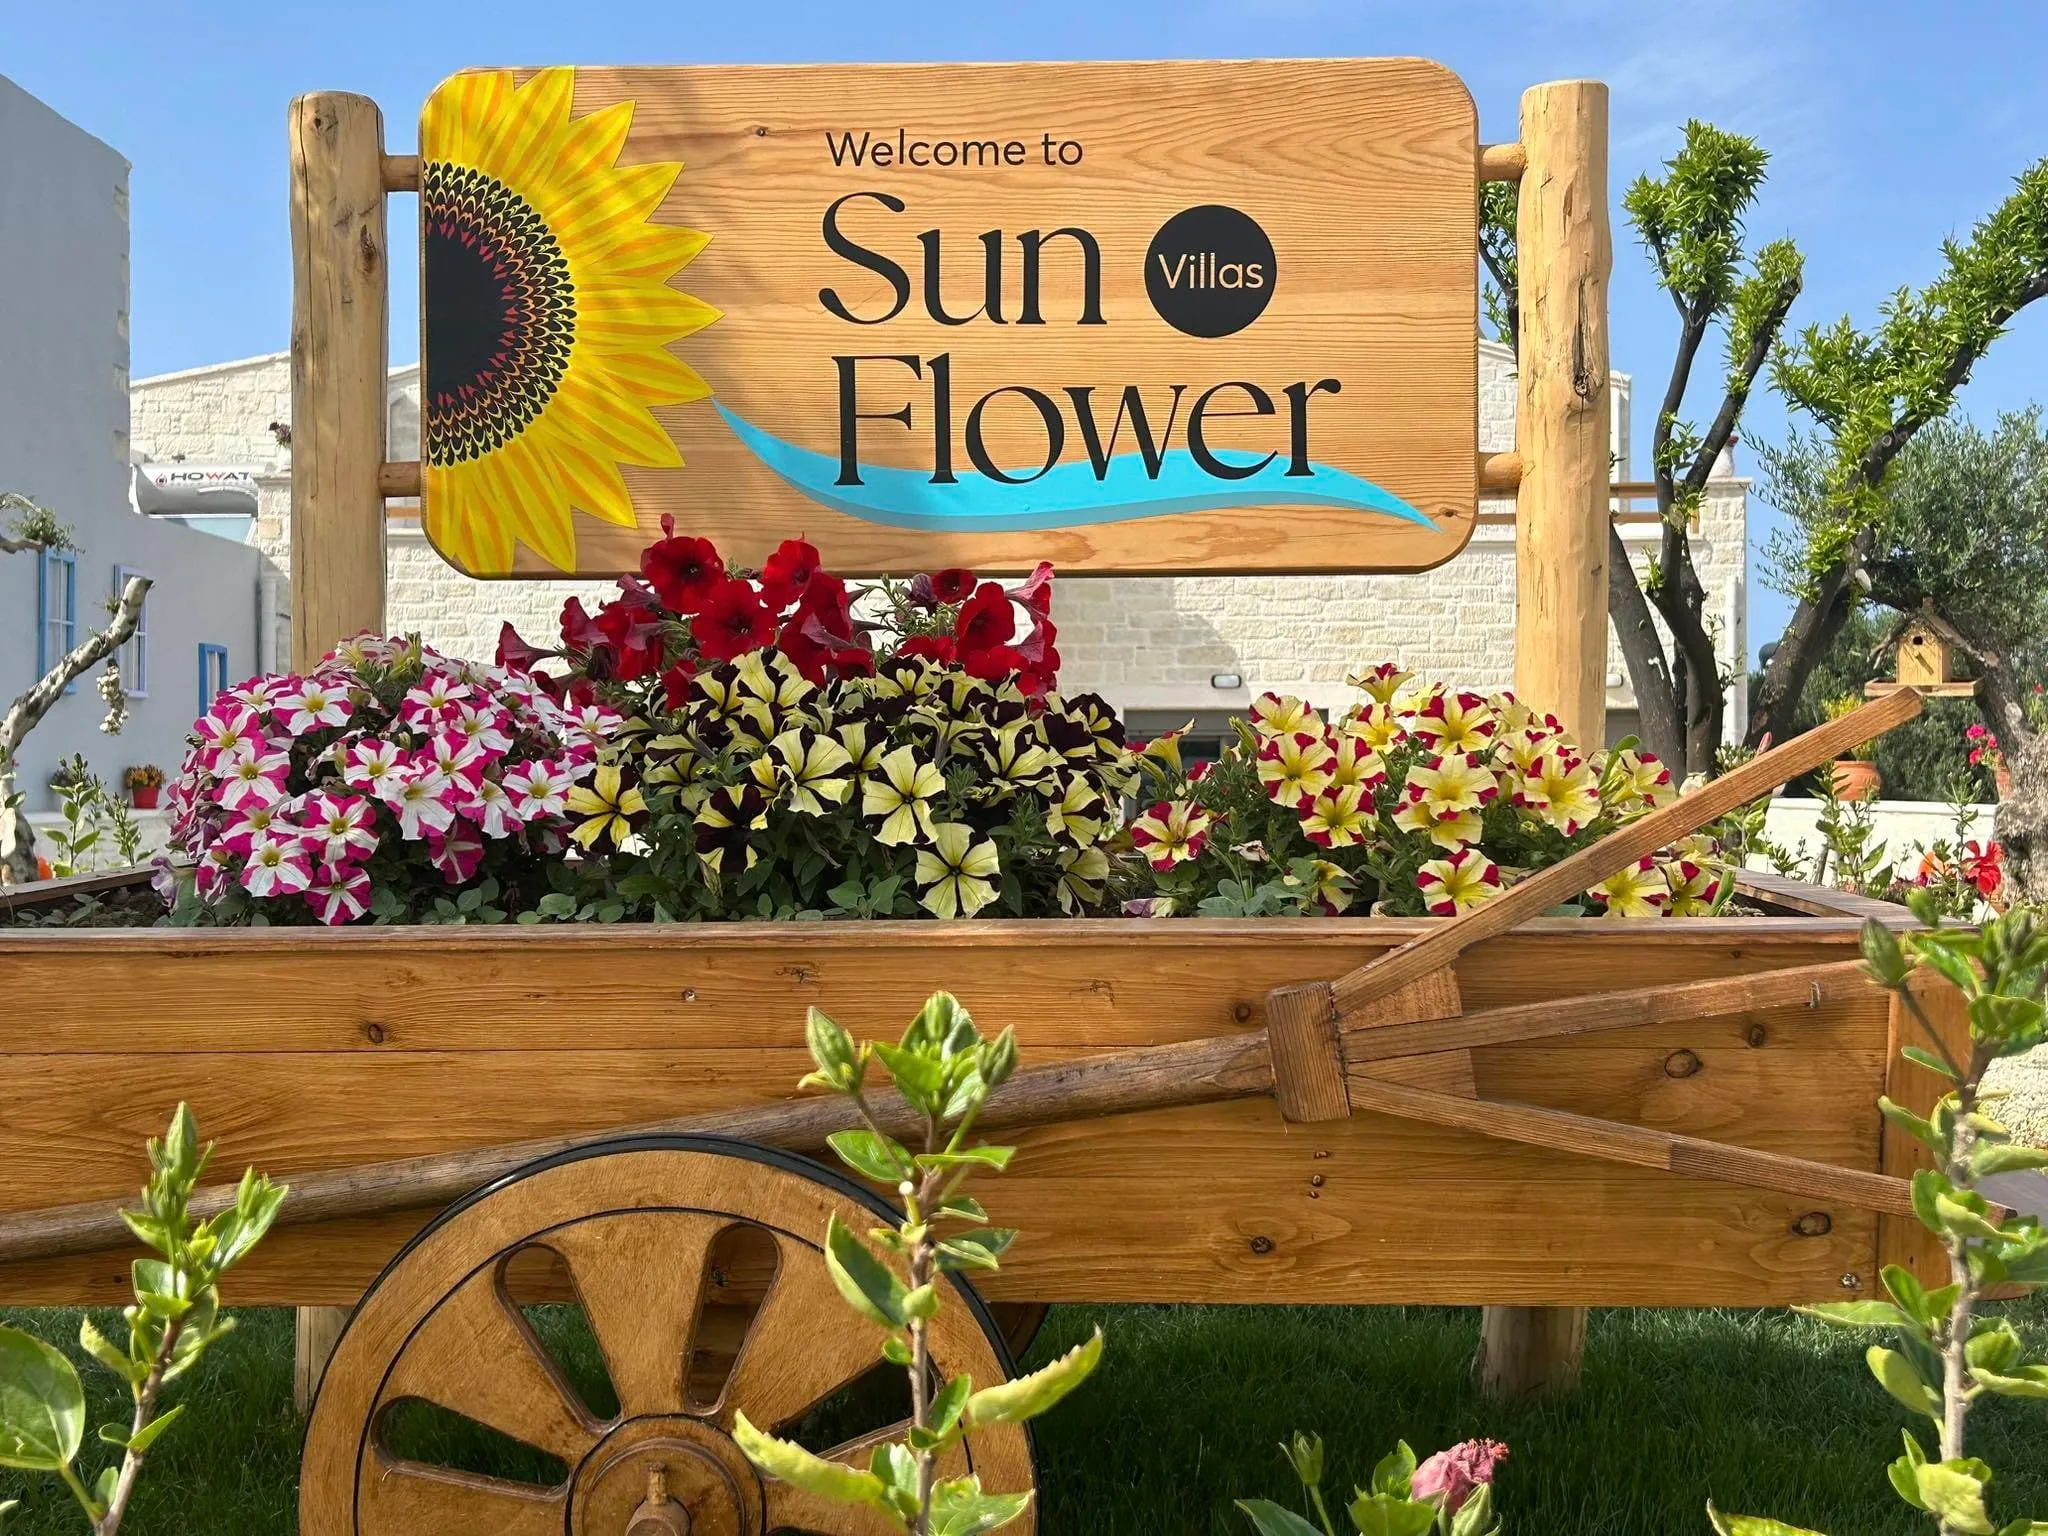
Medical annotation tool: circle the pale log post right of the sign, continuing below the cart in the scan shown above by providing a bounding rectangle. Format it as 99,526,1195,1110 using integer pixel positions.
1479,80,1614,1397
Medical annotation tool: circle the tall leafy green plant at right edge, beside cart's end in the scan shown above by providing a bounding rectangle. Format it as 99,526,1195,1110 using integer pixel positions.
1708,891,2048,1536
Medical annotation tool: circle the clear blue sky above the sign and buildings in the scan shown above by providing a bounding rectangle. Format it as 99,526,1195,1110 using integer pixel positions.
0,0,2048,645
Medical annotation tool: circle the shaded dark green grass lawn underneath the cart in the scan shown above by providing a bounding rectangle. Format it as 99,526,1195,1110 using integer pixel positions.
0,1296,2048,1536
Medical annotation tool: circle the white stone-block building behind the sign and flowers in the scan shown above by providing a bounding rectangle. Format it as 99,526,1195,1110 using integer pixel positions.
131,340,1749,753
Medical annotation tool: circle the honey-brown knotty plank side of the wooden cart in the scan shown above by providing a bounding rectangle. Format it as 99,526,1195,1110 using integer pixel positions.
0,918,1886,1305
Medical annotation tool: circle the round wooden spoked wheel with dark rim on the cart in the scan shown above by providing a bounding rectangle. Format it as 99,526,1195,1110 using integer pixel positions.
299,1137,1036,1536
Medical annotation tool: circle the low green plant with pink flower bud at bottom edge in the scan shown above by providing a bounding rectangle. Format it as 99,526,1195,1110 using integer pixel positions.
1237,1432,1507,1536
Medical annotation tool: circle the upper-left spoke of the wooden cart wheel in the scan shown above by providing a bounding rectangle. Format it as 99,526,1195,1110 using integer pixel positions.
383,1266,600,1466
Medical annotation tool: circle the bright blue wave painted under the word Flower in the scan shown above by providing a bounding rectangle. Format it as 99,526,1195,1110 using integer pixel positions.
711,399,1436,532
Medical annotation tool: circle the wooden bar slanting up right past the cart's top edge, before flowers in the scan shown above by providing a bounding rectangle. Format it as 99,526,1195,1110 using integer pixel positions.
1331,692,1921,1020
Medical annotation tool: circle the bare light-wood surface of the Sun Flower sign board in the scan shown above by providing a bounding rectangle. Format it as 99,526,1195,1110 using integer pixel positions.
422,59,1479,575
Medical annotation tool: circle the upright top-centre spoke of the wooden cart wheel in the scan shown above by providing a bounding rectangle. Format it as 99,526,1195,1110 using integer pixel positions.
545,1210,731,1417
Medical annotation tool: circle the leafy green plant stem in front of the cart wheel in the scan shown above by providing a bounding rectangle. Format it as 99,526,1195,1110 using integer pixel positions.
733,991,1102,1536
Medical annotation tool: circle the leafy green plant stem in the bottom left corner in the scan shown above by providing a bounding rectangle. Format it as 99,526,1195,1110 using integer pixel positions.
0,1104,285,1536
